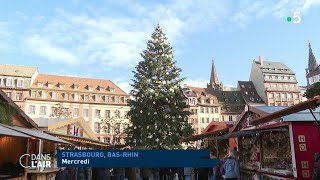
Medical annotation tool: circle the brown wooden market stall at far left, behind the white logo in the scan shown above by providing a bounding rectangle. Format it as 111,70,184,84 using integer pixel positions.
0,90,70,180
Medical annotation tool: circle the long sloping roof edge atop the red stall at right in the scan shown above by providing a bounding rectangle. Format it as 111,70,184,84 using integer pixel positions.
251,96,320,125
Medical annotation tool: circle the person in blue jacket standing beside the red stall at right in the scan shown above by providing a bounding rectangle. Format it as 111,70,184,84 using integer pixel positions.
222,151,240,180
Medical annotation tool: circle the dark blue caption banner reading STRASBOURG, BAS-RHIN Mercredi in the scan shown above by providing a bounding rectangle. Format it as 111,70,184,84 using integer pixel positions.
57,150,220,168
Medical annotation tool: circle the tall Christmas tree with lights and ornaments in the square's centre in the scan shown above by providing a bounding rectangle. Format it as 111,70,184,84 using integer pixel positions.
126,25,193,149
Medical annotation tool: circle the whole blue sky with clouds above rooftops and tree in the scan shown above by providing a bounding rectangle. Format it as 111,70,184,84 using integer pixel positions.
0,0,320,93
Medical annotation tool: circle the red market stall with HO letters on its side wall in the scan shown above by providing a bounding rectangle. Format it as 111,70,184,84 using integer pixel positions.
218,101,320,179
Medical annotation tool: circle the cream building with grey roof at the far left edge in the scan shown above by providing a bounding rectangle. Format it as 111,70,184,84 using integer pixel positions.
0,64,38,110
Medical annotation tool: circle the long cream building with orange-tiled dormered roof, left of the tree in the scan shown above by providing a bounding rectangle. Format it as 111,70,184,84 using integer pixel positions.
26,74,130,144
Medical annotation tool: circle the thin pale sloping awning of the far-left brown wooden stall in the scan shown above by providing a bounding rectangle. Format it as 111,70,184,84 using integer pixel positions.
1,125,71,144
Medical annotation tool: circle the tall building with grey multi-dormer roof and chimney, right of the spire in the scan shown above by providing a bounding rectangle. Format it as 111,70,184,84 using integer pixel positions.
250,56,302,106
